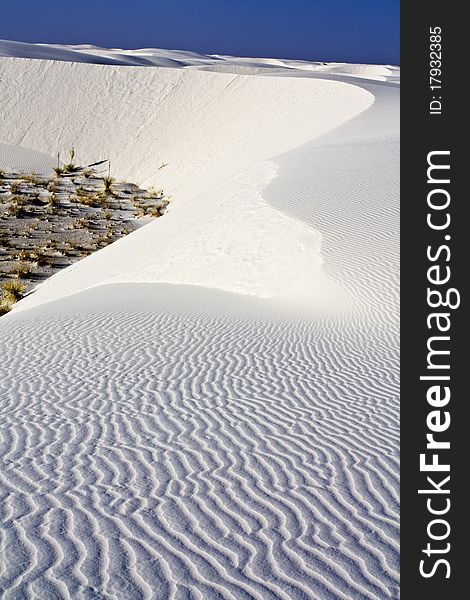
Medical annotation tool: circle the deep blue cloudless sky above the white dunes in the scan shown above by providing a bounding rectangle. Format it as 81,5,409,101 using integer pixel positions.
0,0,399,64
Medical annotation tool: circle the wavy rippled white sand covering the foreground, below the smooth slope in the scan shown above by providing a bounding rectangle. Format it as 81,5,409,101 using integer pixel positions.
0,292,398,600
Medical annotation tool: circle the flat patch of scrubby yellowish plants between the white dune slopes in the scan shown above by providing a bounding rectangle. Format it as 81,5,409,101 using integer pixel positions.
0,158,169,316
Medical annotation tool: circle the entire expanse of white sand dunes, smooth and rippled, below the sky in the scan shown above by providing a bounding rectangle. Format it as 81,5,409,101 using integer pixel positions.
0,42,399,600
